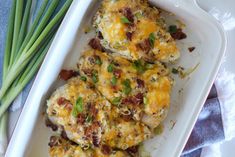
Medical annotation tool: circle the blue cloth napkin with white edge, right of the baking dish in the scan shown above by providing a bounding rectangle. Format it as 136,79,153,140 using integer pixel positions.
181,70,235,157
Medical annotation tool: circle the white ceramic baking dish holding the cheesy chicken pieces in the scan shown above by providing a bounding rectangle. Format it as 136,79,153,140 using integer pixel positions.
6,0,226,157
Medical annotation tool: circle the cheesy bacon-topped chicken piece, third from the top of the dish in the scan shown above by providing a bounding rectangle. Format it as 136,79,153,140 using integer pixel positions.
47,77,151,149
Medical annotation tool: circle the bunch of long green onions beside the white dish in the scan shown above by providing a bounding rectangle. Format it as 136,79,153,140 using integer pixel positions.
0,0,73,156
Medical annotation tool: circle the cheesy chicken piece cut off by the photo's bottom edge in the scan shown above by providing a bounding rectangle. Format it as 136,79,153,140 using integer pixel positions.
49,136,129,157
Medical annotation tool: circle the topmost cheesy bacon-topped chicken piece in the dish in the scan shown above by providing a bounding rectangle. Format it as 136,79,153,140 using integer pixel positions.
94,0,180,62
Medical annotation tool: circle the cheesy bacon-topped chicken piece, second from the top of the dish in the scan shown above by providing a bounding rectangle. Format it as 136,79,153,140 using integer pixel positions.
78,50,172,128
